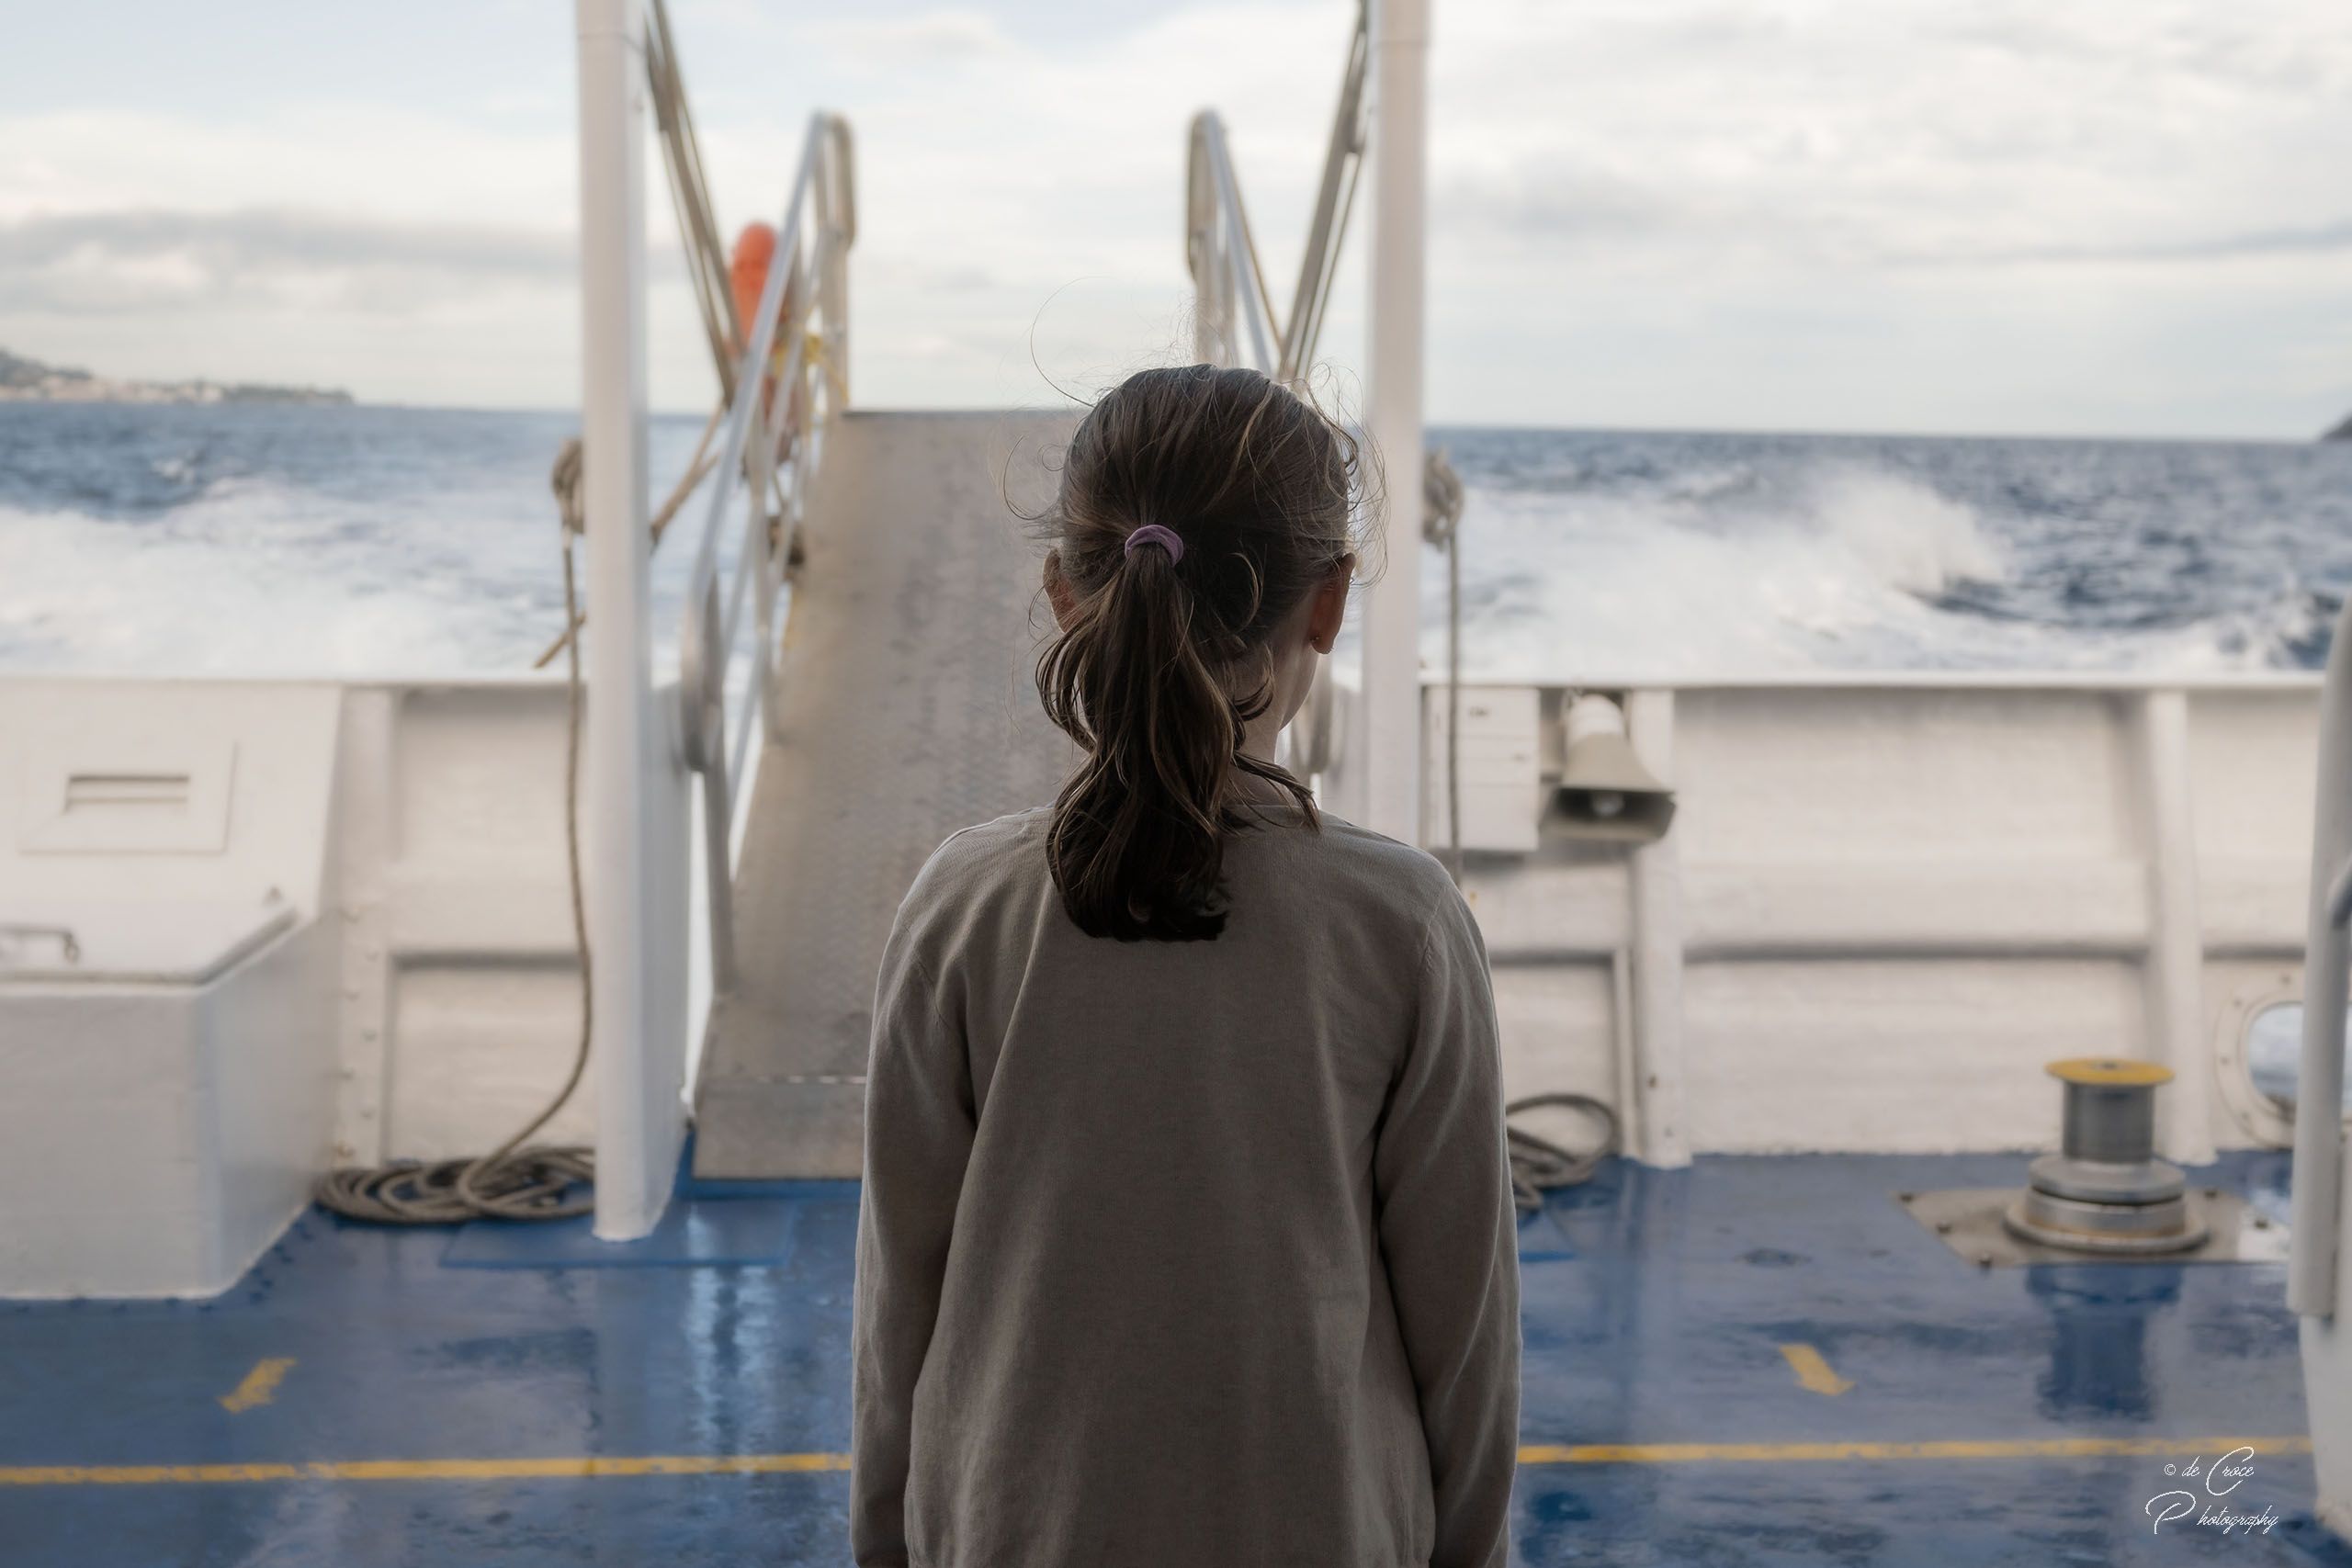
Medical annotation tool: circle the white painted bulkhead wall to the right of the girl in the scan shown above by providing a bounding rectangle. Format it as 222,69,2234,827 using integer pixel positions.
1425,677,2317,1164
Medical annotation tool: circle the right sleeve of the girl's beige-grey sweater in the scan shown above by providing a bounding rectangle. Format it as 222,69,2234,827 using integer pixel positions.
1374,888,1520,1568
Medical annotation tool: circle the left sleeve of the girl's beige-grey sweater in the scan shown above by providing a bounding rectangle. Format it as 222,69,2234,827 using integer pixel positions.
849,909,974,1568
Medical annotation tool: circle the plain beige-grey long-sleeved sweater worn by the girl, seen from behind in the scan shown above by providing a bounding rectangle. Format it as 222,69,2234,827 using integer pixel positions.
852,807,1520,1568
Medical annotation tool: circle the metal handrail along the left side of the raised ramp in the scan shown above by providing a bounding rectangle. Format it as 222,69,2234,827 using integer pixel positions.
677,113,856,995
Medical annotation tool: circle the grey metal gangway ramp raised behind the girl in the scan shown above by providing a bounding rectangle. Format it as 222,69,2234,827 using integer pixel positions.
694,412,1075,1178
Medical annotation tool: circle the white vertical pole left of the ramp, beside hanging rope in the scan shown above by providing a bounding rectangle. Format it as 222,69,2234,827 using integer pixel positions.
574,0,671,1241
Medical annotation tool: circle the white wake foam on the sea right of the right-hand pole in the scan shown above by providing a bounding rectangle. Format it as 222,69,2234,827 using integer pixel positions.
1423,461,2319,680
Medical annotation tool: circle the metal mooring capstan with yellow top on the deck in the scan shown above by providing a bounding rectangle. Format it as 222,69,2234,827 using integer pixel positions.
2002,1055,2206,1253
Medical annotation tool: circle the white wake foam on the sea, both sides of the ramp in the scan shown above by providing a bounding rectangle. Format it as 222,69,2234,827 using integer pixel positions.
0,428,2328,680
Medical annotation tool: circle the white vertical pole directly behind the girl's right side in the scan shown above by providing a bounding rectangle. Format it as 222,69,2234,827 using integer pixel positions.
1348,0,1430,844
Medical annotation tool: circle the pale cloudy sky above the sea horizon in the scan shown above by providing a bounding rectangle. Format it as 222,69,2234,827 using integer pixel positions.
0,0,2352,437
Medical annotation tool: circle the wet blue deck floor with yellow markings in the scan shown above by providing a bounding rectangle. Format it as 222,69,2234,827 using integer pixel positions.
0,1156,2352,1568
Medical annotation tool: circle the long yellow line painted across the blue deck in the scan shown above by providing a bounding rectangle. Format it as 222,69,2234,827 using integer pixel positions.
0,1437,2312,1485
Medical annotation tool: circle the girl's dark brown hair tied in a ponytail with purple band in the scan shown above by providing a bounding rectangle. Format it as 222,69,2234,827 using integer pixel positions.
1037,365,1360,942
